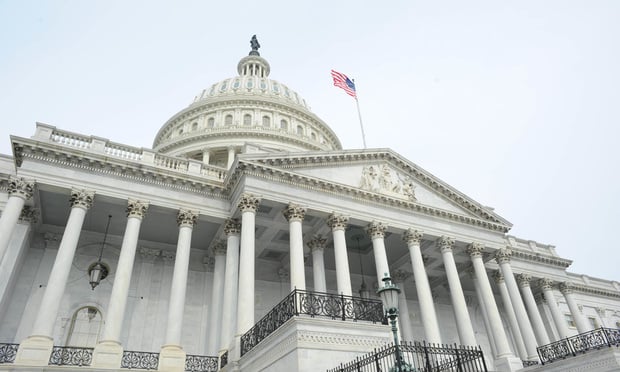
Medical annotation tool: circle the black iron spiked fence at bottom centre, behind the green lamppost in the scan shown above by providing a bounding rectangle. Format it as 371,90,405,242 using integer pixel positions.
327,342,487,372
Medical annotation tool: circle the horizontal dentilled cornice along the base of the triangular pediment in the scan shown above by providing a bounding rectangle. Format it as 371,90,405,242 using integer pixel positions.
226,160,509,233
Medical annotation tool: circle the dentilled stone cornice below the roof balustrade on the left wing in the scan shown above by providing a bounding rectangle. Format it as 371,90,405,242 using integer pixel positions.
13,137,228,199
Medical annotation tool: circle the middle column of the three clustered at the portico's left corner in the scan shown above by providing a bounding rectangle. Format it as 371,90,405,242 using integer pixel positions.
220,218,241,352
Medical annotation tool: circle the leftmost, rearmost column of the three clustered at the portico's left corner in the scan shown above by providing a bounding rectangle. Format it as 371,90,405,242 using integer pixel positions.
207,241,226,356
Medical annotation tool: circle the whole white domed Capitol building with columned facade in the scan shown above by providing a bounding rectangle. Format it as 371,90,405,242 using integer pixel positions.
0,38,620,372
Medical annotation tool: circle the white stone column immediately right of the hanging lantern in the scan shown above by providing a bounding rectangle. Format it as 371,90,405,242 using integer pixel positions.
92,199,148,368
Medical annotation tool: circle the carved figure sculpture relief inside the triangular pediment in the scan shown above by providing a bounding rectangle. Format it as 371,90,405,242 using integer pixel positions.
360,164,417,201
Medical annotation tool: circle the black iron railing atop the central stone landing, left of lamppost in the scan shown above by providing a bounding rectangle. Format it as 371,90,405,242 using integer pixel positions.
241,289,384,355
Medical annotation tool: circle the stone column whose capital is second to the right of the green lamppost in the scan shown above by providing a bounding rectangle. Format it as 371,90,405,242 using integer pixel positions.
436,236,478,346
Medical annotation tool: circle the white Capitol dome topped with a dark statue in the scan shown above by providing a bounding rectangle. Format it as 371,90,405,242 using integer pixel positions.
153,38,342,167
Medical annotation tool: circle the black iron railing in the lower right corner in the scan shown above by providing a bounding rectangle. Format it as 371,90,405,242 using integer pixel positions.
536,328,620,364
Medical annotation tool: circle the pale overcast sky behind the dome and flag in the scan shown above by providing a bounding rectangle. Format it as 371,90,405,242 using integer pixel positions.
0,0,620,280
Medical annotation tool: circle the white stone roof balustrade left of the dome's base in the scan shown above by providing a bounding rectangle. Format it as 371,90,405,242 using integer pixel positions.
33,123,228,182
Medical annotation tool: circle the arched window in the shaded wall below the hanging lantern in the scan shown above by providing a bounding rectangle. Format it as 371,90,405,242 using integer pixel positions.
66,306,103,347
